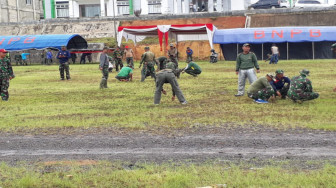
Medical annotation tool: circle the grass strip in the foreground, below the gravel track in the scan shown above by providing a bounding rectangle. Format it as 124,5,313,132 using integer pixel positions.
0,161,336,188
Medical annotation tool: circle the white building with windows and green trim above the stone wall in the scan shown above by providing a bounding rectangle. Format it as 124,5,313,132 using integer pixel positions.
44,0,251,18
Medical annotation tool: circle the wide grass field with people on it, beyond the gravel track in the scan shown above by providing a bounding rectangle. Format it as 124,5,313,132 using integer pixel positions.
0,60,336,132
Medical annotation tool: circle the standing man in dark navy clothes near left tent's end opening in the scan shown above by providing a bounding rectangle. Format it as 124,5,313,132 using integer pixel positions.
56,46,71,80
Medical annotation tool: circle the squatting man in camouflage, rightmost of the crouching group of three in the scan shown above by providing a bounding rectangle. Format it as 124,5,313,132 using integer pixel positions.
287,69,319,103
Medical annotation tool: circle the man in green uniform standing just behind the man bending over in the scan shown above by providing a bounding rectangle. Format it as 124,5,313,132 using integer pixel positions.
139,46,156,82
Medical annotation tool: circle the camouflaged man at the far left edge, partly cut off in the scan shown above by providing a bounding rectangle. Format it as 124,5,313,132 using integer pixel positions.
0,49,15,101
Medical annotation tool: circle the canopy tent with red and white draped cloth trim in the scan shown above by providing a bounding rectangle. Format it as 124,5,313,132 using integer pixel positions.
118,24,216,50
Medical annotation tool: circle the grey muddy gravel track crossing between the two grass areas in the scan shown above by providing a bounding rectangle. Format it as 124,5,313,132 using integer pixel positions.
0,126,336,166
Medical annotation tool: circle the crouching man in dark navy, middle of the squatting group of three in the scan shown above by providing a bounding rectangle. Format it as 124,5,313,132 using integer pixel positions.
273,69,290,99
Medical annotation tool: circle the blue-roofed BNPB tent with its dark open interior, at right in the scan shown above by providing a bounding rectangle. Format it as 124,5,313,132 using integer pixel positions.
213,26,336,60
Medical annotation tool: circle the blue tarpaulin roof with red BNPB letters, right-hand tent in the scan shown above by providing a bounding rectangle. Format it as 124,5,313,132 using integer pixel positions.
213,26,336,44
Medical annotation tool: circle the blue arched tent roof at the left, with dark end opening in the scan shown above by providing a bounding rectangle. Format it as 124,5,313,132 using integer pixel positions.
0,35,88,51
